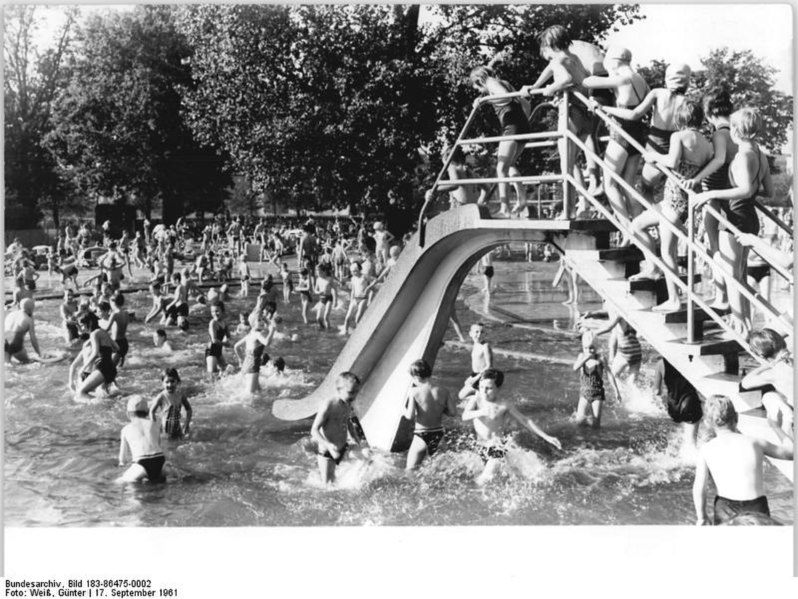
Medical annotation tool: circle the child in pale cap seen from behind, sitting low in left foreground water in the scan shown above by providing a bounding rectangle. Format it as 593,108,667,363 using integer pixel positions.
117,395,166,483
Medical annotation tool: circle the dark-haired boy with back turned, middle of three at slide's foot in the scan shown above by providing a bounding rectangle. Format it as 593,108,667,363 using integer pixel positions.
404,360,457,470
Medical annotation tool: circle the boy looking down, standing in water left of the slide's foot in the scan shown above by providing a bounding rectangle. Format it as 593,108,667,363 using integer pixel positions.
310,372,365,484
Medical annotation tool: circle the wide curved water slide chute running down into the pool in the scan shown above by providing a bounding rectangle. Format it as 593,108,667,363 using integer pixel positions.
273,205,607,451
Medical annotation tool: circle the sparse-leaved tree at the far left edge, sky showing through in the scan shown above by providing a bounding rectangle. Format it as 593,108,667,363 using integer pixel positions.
3,5,77,228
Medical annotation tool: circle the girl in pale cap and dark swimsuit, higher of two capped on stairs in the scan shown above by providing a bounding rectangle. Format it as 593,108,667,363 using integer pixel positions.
582,47,648,232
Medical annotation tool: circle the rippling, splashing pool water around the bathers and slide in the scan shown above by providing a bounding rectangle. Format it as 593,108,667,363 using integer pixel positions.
3,261,793,527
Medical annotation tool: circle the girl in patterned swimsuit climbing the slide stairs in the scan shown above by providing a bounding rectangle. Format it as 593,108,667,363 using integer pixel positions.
629,100,712,312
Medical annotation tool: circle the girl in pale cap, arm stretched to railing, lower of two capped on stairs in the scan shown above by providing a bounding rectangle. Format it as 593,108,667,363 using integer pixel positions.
604,64,691,207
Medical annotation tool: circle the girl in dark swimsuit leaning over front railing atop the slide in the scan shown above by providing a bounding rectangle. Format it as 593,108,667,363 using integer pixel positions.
470,67,531,216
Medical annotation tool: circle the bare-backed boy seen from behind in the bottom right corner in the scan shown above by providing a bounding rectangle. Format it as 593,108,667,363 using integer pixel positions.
693,395,793,526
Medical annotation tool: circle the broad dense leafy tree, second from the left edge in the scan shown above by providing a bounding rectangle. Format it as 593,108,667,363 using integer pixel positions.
46,6,230,223
